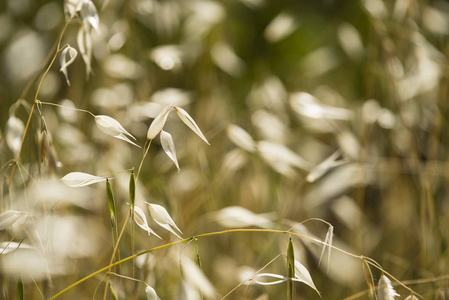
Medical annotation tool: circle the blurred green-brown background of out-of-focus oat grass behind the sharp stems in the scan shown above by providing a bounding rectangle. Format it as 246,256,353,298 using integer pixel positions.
0,0,449,299
